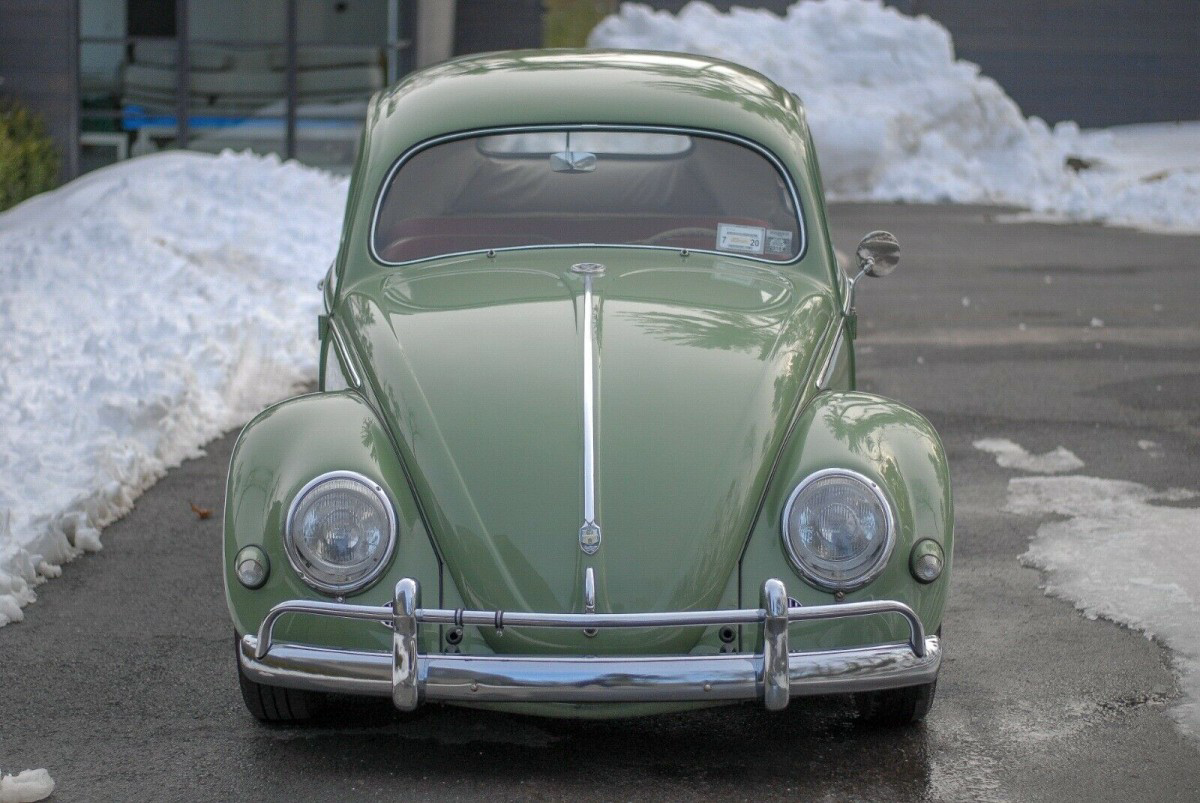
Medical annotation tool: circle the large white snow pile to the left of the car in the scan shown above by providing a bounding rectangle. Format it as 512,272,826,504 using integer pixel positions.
0,152,347,625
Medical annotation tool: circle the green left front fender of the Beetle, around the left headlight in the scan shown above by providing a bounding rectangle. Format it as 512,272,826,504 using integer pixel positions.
224,391,439,649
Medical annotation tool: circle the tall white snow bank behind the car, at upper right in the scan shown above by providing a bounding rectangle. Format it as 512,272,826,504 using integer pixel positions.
588,0,1200,232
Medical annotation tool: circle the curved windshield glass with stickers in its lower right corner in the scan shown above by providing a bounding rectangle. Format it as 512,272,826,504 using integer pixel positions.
373,130,802,263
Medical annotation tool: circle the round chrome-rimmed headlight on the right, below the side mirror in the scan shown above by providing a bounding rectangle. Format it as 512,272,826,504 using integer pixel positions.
784,468,895,591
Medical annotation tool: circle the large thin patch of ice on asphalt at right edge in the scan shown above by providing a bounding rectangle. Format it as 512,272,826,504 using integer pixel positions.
1007,477,1200,738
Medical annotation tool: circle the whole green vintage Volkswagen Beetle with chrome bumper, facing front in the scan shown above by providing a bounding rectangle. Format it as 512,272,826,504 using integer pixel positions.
224,50,953,723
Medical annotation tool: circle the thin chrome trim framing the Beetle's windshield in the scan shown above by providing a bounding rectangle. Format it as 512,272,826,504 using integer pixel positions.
367,122,809,268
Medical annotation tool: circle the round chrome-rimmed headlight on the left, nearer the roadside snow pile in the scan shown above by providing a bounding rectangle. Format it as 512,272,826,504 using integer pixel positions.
283,472,396,594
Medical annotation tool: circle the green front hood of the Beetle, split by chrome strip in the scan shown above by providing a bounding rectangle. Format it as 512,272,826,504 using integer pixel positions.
338,251,834,653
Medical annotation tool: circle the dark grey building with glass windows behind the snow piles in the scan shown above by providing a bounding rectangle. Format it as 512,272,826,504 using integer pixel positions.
0,0,1200,179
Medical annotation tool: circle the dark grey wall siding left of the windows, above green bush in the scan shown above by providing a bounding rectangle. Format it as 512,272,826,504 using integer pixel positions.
0,0,79,180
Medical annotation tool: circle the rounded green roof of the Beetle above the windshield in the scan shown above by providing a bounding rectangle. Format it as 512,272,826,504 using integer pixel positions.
362,49,808,176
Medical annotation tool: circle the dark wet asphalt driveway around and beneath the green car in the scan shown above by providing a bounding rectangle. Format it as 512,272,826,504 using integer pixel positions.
0,205,1200,801
